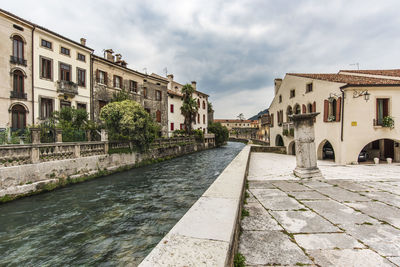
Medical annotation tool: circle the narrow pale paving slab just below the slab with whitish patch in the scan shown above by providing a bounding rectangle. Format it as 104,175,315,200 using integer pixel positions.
294,233,365,250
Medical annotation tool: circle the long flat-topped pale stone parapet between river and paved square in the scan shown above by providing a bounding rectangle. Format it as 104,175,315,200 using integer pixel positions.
139,145,250,267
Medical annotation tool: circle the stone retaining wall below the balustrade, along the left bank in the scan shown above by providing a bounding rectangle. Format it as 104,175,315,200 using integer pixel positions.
0,142,214,201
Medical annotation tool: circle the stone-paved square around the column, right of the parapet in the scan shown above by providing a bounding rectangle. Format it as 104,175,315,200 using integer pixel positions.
239,153,400,267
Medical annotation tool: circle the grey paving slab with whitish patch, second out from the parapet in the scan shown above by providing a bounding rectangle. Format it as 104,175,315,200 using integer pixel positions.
271,211,341,233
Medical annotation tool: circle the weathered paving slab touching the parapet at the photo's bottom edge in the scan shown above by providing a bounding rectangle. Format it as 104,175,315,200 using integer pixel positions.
239,231,312,265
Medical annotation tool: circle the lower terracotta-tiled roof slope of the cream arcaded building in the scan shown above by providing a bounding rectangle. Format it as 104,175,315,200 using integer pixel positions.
287,73,400,85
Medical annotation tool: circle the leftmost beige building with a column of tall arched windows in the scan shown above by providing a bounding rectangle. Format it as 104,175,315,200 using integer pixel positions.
0,9,34,131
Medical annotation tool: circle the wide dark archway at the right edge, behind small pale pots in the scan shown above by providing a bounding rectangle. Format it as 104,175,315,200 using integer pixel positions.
357,139,400,162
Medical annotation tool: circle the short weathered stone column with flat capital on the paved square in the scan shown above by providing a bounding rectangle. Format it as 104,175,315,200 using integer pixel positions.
289,113,322,178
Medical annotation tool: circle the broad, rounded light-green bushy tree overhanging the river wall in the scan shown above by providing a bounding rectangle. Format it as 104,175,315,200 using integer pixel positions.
100,100,160,152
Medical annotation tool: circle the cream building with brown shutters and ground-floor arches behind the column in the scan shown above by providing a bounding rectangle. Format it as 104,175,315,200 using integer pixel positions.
269,70,400,164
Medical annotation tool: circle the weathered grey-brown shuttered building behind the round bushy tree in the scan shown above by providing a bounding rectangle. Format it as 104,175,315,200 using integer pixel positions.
91,49,168,136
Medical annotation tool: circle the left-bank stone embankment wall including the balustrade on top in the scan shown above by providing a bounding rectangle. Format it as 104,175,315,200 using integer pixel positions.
0,137,214,202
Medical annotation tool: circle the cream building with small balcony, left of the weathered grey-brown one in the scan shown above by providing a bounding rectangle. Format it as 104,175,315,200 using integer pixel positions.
33,27,93,123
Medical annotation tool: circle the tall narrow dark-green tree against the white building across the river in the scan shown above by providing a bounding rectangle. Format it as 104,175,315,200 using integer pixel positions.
181,84,199,133
